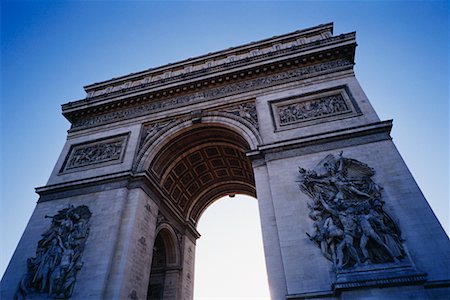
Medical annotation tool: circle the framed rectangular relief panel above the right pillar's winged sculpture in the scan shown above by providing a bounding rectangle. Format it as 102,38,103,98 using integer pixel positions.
272,86,360,130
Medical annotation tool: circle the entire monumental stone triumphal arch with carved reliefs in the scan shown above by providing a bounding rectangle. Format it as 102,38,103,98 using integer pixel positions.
1,24,450,299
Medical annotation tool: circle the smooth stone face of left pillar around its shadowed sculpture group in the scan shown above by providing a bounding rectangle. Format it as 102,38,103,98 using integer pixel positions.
0,186,132,299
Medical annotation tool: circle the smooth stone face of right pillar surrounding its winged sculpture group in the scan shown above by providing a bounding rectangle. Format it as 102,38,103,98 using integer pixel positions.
255,140,450,299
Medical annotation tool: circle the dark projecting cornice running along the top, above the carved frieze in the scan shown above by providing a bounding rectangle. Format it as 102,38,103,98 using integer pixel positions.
63,33,356,127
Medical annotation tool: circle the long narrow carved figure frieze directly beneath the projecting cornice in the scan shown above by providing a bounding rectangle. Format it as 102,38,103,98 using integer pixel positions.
72,58,353,129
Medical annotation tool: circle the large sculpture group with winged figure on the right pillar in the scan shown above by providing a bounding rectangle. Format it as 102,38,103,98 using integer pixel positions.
299,152,406,270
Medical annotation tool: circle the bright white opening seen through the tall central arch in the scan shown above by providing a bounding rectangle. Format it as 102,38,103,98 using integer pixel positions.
194,194,270,299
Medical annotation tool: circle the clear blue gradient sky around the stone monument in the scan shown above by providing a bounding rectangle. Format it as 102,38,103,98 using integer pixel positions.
0,1,450,298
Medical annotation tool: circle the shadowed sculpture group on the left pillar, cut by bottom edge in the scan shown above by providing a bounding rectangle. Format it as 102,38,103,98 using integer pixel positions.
16,205,91,299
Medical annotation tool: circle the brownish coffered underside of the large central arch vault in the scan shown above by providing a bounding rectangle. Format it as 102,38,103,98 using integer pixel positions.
151,124,256,224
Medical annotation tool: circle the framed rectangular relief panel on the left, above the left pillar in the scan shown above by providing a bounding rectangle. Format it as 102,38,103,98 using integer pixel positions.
61,133,129,172
